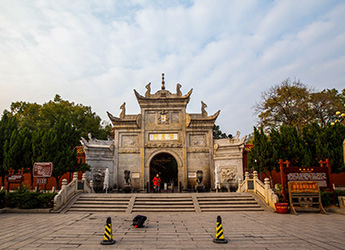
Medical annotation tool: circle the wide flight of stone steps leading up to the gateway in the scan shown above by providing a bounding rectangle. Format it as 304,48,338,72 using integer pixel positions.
63,193,264,213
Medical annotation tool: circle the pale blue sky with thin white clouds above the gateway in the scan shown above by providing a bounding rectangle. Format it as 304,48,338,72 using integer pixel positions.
0,0,345,135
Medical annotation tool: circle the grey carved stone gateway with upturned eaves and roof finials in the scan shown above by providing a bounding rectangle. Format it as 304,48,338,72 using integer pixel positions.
82,75,244,191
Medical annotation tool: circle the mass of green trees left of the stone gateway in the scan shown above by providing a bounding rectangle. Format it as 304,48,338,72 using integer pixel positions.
0,95,103,188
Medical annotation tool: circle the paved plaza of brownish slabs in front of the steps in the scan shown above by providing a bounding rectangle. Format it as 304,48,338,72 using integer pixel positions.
0,211,345,249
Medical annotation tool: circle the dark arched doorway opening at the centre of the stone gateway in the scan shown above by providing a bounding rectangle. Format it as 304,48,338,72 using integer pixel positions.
150,153,178,190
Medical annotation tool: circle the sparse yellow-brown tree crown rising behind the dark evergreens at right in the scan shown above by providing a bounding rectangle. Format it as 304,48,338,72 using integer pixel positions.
255,79,345,131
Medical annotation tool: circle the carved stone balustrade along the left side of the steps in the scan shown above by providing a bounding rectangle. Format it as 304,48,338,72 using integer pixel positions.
54,172,93,211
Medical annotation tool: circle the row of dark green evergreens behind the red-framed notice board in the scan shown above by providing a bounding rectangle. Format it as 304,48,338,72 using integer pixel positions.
248,123,345,173
